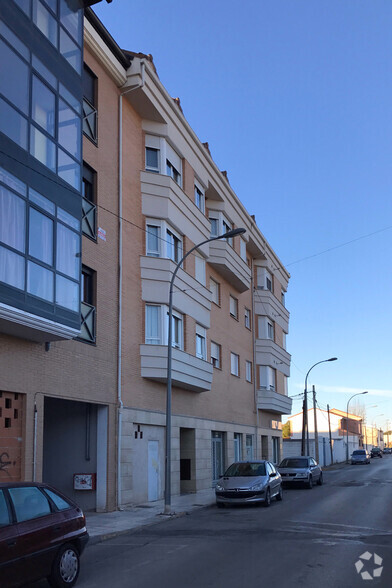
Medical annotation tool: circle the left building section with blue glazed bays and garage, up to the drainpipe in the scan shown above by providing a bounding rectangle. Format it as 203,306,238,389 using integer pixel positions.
0,0,118,509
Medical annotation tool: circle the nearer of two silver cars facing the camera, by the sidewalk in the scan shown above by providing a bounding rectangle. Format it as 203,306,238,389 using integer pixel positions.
215,460,283,507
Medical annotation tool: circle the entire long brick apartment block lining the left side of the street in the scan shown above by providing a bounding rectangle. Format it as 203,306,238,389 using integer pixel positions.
0,0,291,510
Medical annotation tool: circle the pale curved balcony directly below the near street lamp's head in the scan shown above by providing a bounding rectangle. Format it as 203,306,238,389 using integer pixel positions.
208,240,251,292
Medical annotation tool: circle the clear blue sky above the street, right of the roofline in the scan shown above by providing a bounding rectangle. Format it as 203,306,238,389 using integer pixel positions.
95,0,392,427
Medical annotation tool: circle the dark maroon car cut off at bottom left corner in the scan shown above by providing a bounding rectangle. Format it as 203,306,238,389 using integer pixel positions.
0,482,88,588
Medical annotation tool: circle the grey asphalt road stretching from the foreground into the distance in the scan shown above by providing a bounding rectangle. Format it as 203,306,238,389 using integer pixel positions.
34,455,392,588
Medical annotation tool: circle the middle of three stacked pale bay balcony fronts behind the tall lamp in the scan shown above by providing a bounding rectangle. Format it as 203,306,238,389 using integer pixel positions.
140,256,211,329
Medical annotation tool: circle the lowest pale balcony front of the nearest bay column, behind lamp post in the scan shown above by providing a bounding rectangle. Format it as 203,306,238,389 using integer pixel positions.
140,345,213,392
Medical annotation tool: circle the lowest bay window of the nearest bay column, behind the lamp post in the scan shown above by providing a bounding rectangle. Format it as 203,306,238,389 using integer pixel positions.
145,304,184,349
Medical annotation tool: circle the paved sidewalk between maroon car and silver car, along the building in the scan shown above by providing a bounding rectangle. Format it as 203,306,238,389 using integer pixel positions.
86,488,215,545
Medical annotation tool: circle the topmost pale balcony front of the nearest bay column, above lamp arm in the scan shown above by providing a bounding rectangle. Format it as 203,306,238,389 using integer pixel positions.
140,171,210,255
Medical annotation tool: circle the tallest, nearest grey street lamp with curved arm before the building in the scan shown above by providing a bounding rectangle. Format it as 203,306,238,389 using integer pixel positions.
164,229,246,514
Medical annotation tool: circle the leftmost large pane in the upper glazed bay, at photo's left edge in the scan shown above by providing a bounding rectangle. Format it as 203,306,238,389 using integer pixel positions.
0,40,29,114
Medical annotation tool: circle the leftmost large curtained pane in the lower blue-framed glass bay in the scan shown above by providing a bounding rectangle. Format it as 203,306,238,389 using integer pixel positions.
0,186,26,253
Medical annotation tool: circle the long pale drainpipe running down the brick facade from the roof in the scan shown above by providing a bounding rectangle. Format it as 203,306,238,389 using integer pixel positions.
117,61,146,510
